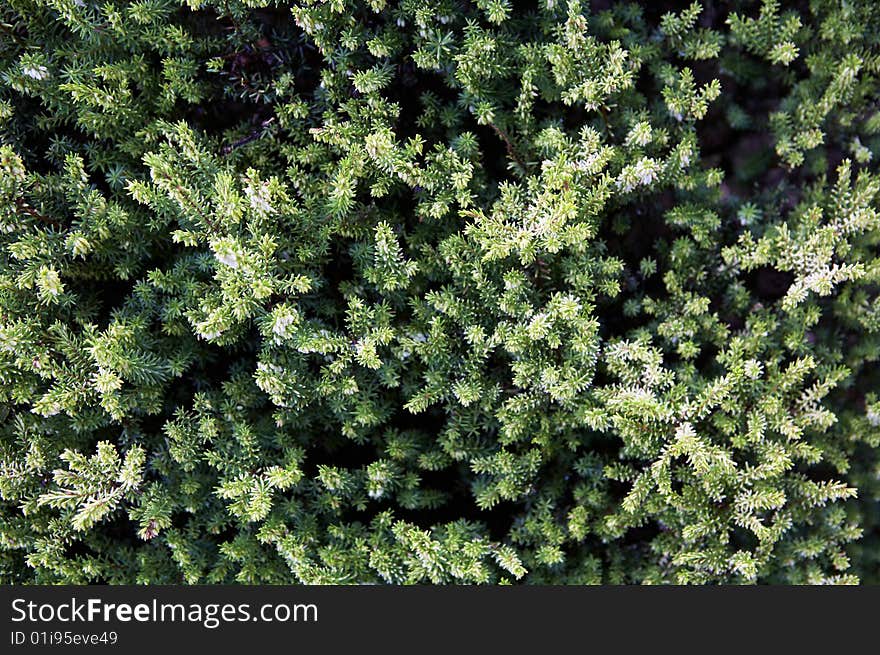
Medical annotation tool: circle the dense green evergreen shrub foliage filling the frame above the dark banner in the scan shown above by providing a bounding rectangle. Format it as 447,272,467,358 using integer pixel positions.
0,0,880,584
